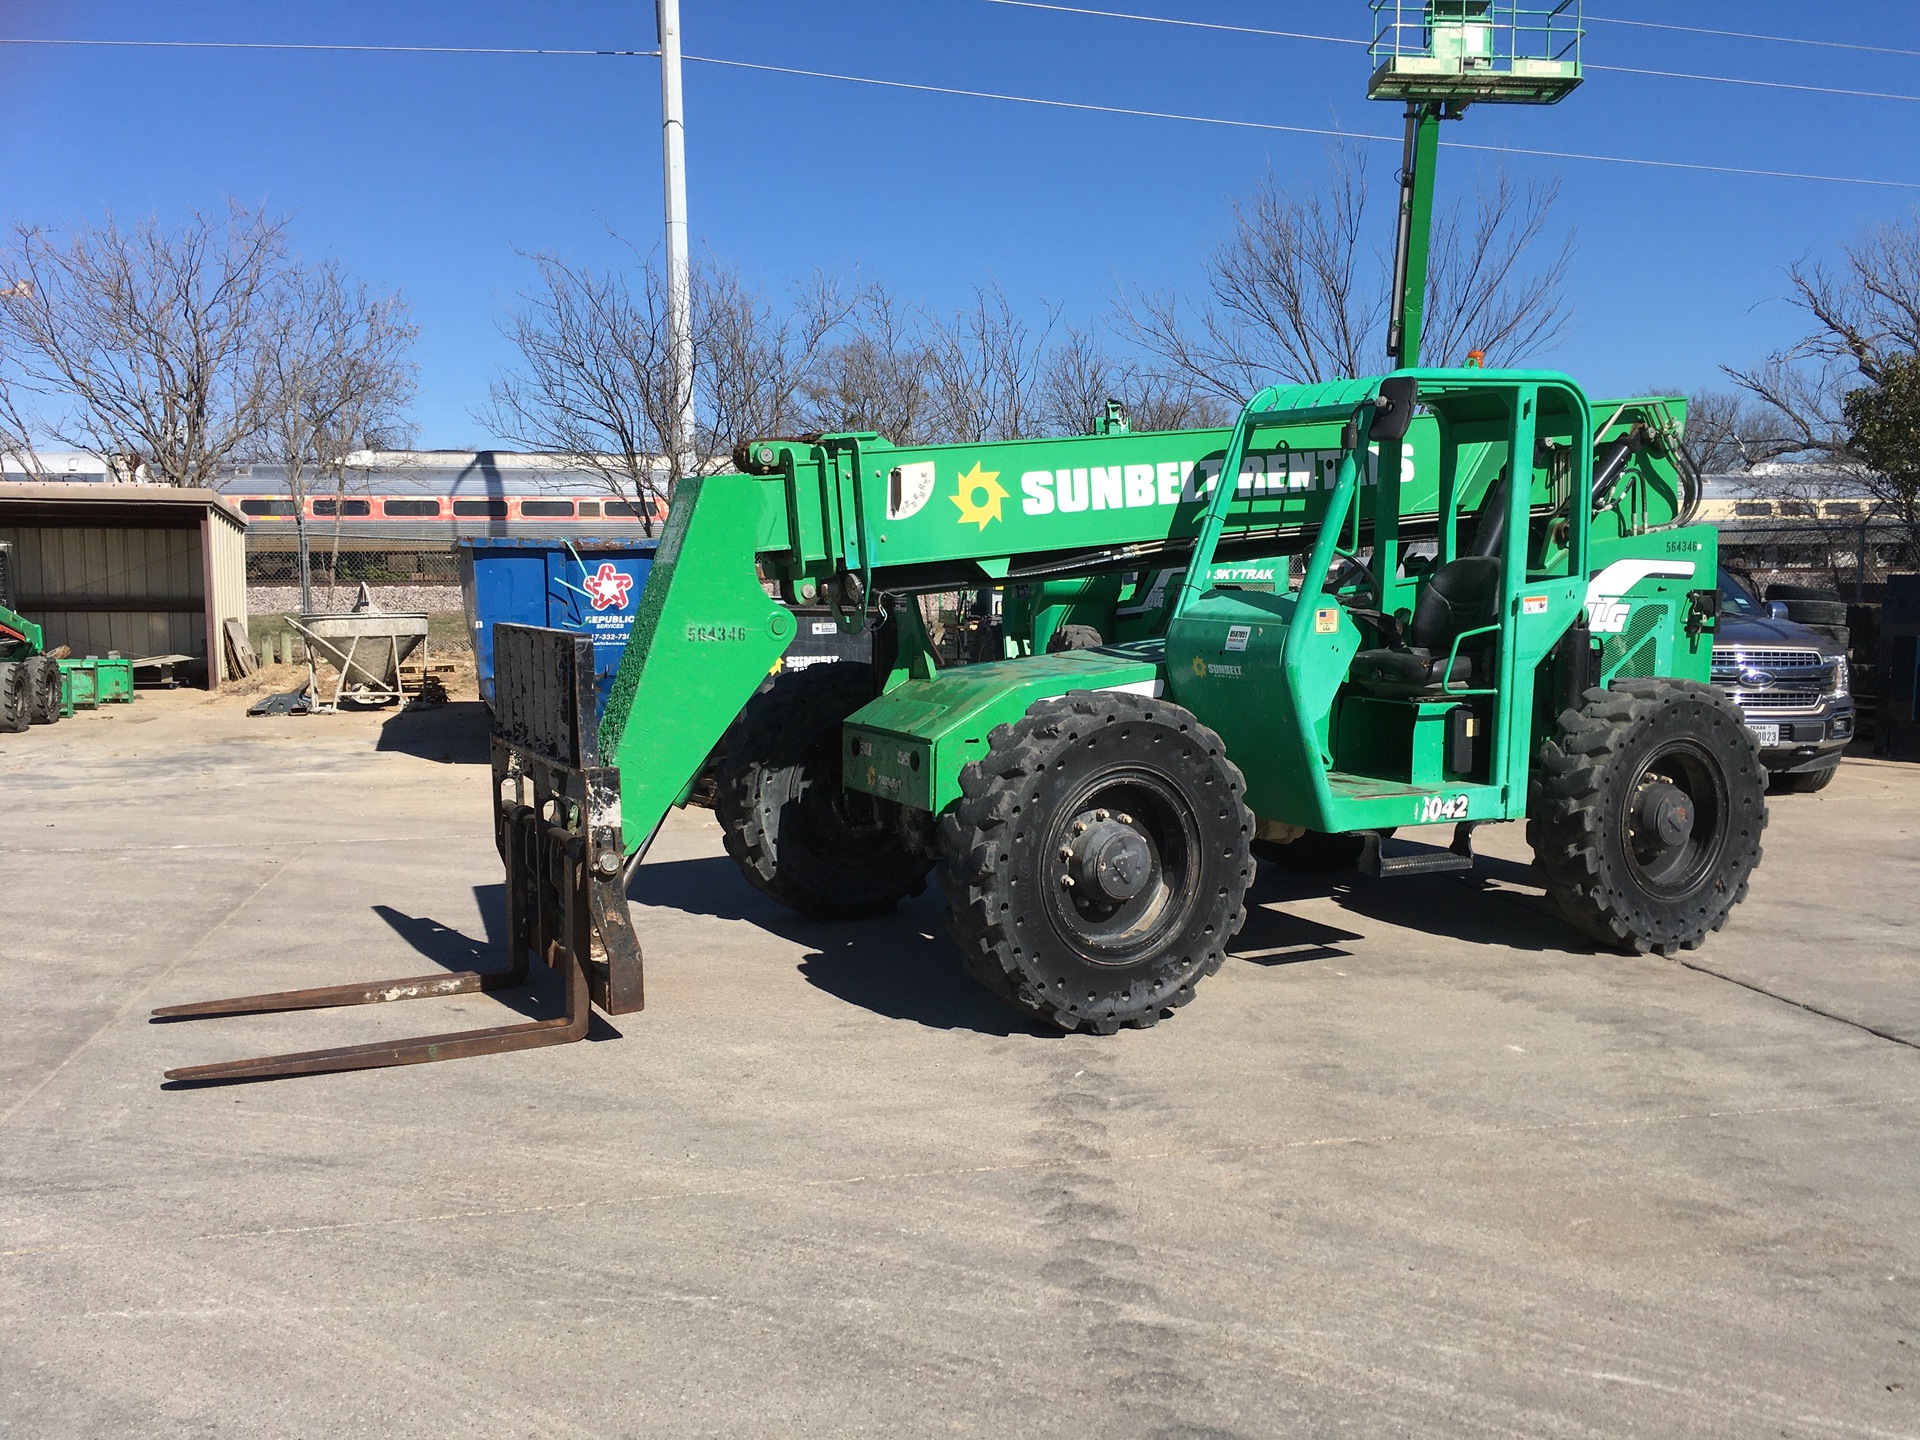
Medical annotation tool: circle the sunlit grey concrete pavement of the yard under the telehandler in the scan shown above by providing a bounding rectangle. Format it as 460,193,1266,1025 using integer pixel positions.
0,693,1920,1440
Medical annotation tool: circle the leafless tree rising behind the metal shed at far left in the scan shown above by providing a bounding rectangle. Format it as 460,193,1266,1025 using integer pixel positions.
0,205,288,486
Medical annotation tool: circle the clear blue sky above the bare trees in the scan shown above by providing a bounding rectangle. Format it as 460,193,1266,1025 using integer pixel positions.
0,0,1920,447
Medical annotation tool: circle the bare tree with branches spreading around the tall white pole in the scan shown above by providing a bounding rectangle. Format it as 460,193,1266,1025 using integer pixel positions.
474,255,849,534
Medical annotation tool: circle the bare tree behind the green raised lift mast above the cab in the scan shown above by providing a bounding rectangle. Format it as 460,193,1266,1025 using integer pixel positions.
1116,150,1572,403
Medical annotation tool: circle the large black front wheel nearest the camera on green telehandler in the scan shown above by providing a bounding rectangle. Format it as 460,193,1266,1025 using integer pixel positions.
941,691,1254,1035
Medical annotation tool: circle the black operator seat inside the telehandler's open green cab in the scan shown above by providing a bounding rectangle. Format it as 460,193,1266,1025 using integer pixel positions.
1348,470,1509,697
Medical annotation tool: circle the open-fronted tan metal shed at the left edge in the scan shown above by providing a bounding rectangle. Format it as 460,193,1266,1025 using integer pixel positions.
0,482,248,689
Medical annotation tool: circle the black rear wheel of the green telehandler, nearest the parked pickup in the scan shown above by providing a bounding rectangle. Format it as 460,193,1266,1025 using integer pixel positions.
1526,680,1766,956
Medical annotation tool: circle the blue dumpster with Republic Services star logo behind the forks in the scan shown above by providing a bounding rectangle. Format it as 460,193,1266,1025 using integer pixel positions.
461,538,655,705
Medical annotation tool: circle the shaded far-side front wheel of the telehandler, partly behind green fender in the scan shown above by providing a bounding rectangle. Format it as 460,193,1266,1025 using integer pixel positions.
714,662,933,920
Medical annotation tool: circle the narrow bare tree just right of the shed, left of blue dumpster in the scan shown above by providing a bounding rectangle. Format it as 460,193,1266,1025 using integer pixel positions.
248,261,419,611
